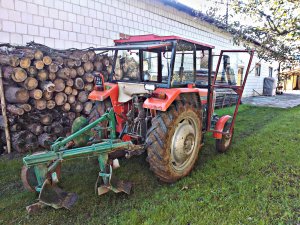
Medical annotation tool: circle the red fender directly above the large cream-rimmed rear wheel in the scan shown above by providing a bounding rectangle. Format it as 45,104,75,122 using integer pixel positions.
143,88,207,111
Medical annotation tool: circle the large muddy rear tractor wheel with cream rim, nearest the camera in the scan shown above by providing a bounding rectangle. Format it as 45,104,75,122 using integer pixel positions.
146,95,202,183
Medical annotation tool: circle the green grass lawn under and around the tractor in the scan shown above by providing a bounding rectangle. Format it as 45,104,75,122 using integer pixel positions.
0,105,300,224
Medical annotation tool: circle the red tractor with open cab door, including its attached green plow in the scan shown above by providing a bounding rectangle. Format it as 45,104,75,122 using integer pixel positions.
22,35,253,212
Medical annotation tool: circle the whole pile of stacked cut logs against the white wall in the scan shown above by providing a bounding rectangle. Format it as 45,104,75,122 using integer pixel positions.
0,43,111,152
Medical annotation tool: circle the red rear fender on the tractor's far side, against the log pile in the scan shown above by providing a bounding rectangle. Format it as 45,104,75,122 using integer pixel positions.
88,83,119,101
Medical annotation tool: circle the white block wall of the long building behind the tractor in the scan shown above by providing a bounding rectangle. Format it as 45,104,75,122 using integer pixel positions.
0,0,277,96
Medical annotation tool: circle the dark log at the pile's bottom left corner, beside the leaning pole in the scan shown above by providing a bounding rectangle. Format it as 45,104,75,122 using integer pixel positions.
12,130,38,153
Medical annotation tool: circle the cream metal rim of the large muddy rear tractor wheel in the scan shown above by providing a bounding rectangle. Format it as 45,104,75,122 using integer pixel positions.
171,117,199,172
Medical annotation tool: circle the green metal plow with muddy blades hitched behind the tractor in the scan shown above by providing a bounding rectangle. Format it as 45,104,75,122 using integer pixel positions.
21,109,144,213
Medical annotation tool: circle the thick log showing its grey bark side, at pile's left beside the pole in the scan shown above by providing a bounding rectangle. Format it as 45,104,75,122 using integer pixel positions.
4,86,29,103
